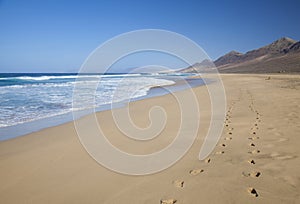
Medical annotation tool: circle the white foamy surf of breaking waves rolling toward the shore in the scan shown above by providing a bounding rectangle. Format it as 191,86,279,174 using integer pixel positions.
0,74,174,127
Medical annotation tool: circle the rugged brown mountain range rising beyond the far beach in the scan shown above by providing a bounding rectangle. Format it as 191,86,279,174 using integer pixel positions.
181,37,300,73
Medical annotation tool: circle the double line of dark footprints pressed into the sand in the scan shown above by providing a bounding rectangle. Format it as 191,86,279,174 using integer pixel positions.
160,96,261,204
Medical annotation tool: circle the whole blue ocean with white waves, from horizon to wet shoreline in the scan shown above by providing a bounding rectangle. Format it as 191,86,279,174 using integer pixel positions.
0,73,202,140
